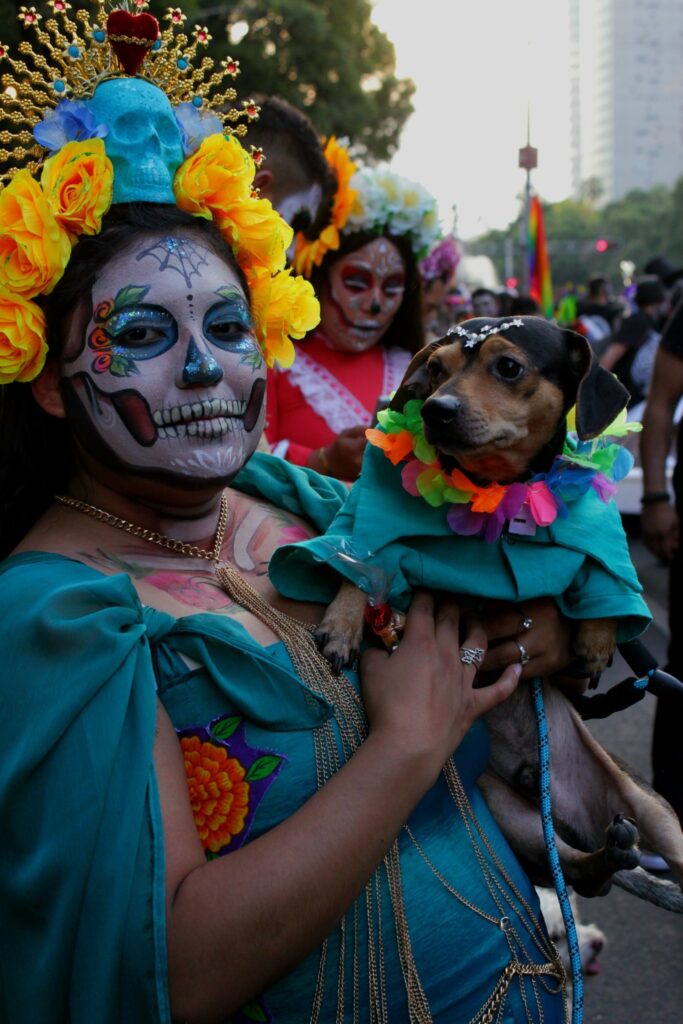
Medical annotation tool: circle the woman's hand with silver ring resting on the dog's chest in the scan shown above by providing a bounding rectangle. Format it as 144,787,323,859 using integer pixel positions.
361,591,519,777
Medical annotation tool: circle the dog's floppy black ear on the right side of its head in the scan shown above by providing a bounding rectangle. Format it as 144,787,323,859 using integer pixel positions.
564,331,630,441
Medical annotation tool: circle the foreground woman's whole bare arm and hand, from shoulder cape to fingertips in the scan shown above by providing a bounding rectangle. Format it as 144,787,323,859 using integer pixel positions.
160,593,518,1021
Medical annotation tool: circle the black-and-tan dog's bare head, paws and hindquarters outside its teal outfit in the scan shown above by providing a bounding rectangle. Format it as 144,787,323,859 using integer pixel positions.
318,317,683,912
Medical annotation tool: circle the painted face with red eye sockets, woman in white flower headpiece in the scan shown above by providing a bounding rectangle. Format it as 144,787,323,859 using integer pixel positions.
321,238,405,352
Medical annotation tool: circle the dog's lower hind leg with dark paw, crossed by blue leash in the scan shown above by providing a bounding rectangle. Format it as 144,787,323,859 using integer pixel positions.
478,771,639,896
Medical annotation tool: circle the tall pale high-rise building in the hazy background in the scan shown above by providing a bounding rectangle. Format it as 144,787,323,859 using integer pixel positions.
569,0,683,201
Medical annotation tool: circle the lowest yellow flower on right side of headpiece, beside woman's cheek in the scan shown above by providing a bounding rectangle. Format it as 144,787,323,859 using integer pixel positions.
247,267,321,368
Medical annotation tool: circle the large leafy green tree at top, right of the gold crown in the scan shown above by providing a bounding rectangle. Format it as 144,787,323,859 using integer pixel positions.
199,0,415,160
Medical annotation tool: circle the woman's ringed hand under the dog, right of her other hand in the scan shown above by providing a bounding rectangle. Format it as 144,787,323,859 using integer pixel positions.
481,597,588,692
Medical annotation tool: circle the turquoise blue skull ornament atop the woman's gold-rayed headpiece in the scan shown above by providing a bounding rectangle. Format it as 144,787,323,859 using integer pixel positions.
87,78,184,204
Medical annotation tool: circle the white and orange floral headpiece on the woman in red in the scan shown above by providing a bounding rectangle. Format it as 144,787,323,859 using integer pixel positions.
294,147,438,276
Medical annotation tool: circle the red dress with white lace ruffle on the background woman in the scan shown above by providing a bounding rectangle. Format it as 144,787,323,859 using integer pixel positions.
265,331,411,466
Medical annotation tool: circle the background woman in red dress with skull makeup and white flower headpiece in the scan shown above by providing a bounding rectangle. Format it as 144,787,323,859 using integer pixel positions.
266,156,437,480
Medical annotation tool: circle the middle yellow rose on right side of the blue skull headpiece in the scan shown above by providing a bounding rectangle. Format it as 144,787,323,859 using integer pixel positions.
214,193,294,273
